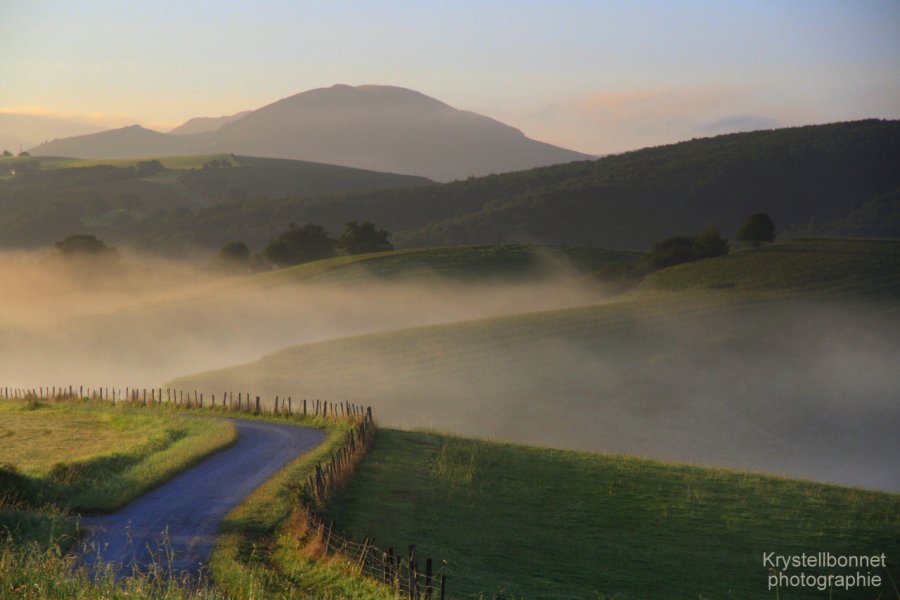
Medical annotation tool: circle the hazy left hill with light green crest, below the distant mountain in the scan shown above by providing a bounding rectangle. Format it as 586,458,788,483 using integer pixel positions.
0,155,432,253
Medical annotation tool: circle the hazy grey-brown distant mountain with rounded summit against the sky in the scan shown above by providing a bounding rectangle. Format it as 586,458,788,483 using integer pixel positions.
32,85,590,181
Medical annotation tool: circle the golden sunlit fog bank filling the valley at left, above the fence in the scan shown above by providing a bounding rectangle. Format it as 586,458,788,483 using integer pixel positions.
0,252,604,388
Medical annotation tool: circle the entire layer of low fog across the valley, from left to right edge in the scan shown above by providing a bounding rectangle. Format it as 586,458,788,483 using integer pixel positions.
0,254,900,491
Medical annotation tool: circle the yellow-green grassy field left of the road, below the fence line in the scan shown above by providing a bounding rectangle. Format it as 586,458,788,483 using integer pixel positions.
0,399,236,512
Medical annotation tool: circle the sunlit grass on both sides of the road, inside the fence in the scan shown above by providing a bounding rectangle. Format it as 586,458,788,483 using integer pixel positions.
0,400,393,599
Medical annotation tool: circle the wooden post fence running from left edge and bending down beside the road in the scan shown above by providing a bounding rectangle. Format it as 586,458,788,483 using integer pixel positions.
0,385,447,600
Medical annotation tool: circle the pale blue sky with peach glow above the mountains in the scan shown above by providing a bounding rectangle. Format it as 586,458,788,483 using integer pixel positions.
0,0,900,154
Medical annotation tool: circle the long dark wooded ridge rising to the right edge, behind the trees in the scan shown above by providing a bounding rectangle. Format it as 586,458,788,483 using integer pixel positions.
123,121,900,249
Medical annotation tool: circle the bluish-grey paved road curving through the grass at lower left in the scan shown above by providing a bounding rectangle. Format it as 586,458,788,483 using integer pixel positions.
81,419,325,575
